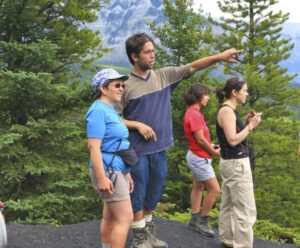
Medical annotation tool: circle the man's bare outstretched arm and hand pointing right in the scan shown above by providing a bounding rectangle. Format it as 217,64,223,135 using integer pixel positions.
190,48,243,73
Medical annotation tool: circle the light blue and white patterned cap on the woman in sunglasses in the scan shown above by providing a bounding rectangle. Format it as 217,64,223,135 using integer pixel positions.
91,69,128,93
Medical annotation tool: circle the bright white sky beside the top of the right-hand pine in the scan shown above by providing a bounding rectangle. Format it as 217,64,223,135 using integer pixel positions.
194,0,300,23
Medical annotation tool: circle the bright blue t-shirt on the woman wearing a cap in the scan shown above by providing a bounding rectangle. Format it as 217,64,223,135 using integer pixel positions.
85,100,130,172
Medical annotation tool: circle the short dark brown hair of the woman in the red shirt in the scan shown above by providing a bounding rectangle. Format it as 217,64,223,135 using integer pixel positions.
184,83,210,106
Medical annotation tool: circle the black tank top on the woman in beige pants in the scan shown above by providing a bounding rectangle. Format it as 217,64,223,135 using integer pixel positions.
216,104,249,159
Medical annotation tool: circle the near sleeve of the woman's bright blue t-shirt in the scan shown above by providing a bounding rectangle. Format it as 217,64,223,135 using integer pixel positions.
86,109,106,139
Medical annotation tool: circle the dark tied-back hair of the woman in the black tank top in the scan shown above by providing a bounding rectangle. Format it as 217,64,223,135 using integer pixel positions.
216,77,246,104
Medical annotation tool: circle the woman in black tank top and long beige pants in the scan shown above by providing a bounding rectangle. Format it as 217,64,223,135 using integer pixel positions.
216,78,261,248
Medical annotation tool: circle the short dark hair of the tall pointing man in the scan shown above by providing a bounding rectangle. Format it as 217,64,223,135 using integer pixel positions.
125,33,155,65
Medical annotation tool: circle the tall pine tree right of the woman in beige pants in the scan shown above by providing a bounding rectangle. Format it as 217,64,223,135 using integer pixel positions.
214,0,300,229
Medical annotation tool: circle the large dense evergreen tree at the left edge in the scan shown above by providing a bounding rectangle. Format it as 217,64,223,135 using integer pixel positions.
0,0,105,224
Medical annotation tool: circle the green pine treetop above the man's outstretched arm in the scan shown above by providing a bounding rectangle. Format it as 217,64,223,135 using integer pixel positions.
149,0,212,67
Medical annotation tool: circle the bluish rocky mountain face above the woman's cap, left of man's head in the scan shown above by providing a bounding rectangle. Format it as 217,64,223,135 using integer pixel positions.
90,0,164,66
